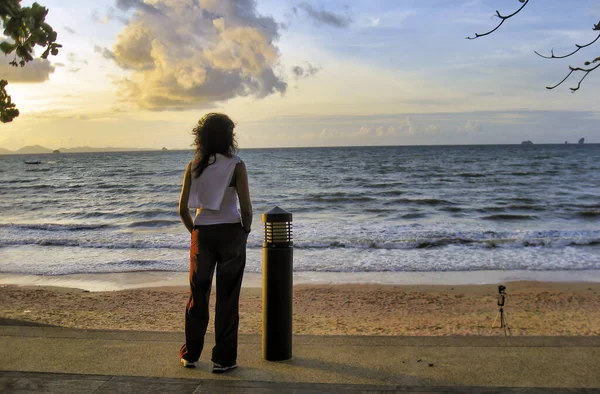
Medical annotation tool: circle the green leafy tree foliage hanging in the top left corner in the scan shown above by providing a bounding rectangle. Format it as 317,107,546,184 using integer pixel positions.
0,0,62,123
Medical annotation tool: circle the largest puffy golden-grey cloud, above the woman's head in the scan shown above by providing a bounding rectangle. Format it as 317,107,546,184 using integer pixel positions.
107,0,287,110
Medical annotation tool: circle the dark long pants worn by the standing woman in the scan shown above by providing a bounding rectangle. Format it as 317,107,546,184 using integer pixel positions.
179,223,246,366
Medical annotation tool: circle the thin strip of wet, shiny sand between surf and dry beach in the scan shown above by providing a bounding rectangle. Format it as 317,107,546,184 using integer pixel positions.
0,270,600,292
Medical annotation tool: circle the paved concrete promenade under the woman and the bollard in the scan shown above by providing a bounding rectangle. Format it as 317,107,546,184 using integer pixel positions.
0,319,600,393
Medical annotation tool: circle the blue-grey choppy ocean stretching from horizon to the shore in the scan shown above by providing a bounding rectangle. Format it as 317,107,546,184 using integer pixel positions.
0,144,600,277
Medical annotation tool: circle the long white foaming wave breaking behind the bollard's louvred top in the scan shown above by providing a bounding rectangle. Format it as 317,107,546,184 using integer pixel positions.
0,229,600,250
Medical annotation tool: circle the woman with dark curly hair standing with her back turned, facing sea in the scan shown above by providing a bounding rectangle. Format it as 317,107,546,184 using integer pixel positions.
179,113,252,373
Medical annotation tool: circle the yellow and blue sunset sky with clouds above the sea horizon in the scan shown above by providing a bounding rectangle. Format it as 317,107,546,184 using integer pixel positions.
0,0,600,150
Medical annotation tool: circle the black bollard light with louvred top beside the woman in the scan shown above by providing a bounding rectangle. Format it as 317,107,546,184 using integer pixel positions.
262,207,294,361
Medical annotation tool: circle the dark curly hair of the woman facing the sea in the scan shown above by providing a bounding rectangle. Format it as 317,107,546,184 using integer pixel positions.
192,112,238,178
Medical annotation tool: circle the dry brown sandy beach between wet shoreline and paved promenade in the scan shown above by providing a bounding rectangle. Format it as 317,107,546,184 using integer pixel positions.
0,282,600,336
